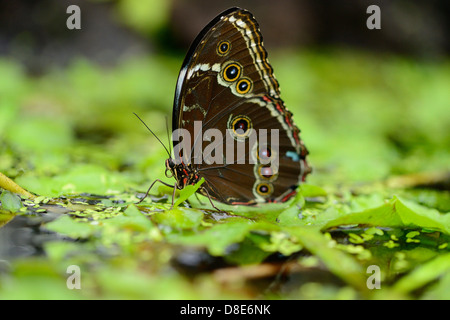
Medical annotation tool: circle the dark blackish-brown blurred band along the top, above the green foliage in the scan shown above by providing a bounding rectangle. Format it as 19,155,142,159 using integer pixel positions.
0,0,450,74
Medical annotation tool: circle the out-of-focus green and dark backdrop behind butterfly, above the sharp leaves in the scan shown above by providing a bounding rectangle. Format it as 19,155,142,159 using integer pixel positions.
0,0,450,195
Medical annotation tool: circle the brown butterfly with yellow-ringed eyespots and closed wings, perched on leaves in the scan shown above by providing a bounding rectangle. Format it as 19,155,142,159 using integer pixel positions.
141,7,311,206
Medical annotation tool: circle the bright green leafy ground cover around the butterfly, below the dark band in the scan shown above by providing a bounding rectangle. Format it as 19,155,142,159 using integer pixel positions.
0,48,450,299
